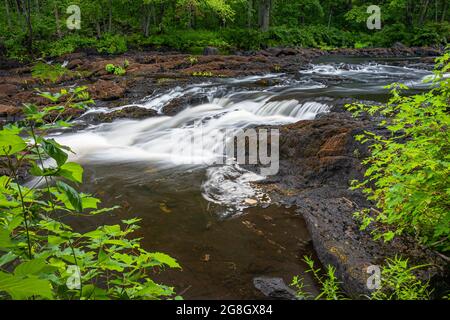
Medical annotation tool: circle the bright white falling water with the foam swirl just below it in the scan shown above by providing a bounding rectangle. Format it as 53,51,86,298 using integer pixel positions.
57,88,329,214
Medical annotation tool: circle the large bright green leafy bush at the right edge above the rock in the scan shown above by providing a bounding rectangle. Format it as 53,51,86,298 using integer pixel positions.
348,53,450,252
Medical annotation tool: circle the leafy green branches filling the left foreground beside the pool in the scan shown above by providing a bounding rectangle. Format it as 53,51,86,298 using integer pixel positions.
0,87,180,300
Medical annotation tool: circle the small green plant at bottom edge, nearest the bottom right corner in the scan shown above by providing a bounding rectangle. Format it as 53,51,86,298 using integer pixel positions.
370,257,432,300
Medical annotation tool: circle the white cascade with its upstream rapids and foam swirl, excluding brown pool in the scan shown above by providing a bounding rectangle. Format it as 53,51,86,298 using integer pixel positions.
51,63,431,215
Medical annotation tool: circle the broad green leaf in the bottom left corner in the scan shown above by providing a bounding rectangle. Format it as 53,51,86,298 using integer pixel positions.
0,272,53,300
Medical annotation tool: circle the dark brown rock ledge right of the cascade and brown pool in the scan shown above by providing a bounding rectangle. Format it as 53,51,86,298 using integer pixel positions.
261,106,450,299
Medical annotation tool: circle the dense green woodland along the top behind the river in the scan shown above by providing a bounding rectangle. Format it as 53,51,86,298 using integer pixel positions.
0,0,450,59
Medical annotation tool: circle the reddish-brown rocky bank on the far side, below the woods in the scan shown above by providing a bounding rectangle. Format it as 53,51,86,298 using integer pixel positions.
0,47,442,122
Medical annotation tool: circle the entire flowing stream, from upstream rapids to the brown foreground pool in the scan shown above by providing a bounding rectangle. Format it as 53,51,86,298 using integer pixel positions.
51,58,432,299
